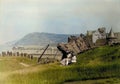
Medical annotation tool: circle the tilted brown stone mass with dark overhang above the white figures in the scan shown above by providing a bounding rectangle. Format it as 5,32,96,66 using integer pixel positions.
57,35,91,58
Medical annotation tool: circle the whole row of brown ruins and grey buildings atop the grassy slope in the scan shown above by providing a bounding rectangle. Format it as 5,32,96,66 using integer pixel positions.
57,28,120,65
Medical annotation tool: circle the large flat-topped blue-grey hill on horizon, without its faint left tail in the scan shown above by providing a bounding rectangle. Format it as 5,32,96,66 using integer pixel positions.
14,32,76,46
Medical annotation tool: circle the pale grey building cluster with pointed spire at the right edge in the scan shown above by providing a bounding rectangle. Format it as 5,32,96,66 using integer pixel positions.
87,27,120,46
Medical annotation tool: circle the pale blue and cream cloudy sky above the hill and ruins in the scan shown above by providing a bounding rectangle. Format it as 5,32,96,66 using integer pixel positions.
0,0,120,44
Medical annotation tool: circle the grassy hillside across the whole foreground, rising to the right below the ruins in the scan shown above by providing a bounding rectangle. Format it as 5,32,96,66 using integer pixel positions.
0,46,120,84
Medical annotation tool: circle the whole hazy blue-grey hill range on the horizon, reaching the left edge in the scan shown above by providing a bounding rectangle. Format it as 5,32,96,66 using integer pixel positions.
0,32,78,52
